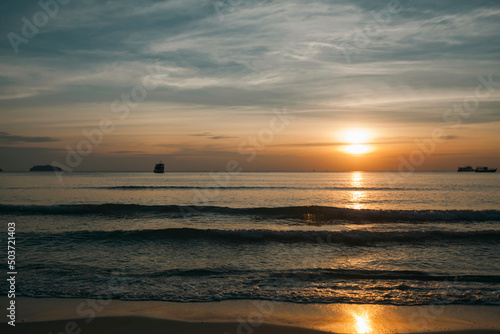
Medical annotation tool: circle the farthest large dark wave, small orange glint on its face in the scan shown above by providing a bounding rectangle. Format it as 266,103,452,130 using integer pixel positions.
0,204,500,223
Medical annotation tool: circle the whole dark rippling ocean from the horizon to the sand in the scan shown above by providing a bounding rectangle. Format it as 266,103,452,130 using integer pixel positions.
0,172,500,305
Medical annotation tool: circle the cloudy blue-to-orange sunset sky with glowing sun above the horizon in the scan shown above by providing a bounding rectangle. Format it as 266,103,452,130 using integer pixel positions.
0,0,500,171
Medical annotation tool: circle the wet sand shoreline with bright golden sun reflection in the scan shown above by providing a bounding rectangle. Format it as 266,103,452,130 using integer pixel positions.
0,296,500,334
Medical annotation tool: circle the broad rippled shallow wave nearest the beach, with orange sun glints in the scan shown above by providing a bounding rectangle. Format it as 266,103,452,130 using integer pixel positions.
10,263,500,306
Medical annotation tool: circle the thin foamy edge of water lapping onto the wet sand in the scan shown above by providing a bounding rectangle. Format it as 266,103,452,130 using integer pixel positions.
16,290,500,306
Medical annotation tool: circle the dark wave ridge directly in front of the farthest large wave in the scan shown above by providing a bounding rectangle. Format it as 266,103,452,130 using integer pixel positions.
19,228,500,246
